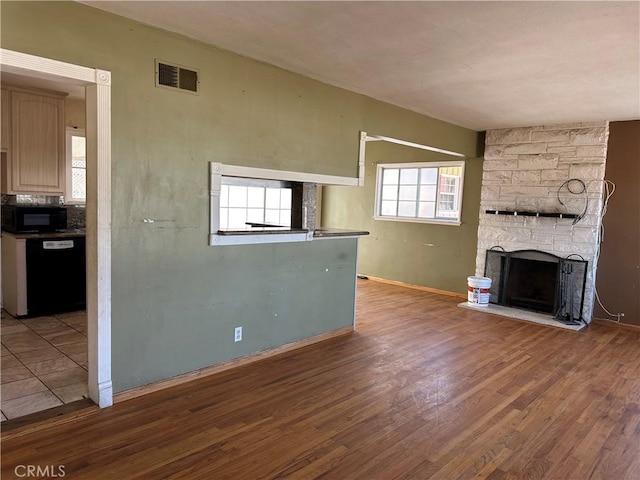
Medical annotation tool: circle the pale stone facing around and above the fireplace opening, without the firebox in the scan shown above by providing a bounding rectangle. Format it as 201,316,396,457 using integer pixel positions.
476,122,609,322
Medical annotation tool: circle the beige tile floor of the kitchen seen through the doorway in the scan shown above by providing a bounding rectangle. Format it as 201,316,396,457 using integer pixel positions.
0,311,87,422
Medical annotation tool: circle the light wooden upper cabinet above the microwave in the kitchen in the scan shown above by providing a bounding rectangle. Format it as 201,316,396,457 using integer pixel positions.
7,90,66,195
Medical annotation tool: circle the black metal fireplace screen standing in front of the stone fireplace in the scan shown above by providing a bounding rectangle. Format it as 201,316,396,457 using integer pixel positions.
484,250,588,323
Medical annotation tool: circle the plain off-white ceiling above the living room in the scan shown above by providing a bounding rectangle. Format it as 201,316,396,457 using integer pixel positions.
83,1,640,130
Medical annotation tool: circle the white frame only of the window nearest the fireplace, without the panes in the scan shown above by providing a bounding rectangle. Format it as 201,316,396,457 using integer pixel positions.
373,160,465,226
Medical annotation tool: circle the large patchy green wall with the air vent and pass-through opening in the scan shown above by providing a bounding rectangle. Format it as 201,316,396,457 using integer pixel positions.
0,1,477,392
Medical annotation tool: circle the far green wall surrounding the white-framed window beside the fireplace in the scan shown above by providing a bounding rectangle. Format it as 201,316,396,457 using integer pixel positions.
322,138,482,293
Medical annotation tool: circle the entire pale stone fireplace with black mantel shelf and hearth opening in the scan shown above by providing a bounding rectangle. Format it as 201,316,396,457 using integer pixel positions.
476,122,609,322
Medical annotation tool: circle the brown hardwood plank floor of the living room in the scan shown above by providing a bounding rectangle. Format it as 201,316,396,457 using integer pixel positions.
1,281,640,480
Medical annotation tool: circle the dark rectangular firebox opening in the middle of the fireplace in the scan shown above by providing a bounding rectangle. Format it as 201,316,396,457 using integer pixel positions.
505,258,558,314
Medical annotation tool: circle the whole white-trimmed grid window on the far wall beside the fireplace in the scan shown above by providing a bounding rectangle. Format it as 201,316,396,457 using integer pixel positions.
374,161,464,225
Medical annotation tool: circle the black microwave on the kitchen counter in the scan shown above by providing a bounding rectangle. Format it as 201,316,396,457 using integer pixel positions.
2,205,67,233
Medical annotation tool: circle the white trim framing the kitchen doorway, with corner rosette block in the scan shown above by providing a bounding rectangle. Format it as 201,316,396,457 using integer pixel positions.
0,48,113,408
